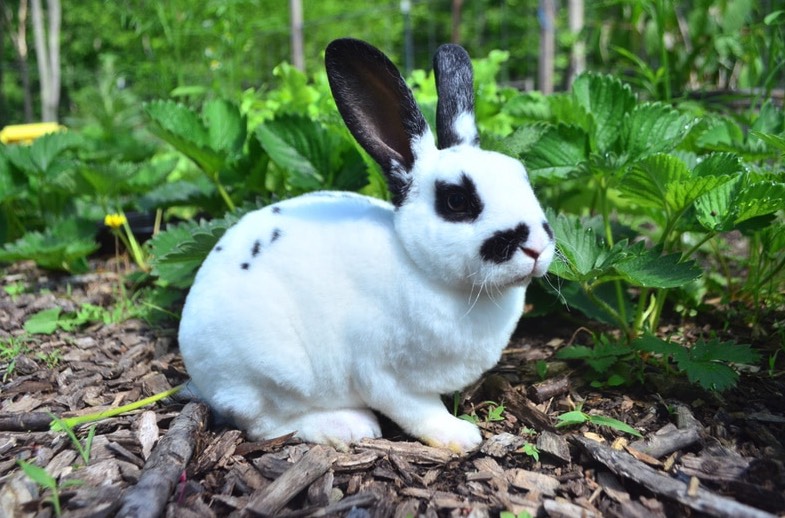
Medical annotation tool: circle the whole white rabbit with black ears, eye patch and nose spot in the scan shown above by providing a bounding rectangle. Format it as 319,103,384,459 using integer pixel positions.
179,39,554,452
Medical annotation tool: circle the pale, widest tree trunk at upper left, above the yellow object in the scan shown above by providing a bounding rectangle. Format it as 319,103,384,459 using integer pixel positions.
30,0,62,122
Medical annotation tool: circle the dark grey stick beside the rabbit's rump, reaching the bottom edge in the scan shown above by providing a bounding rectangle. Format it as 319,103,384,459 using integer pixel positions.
117,402,208,518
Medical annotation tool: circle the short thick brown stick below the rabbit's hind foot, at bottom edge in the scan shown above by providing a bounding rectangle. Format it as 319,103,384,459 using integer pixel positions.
242,445,337,516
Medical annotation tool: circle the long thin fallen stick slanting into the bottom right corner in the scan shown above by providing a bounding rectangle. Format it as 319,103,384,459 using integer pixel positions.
570,436,776,518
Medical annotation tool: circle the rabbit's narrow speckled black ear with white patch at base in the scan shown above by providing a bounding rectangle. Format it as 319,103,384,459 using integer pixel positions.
433,44,480,149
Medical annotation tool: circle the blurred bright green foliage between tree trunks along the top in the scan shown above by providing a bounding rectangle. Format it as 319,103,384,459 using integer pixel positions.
0,0,785,126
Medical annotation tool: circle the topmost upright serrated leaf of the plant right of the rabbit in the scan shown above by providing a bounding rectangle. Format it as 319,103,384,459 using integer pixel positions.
572,73,636,154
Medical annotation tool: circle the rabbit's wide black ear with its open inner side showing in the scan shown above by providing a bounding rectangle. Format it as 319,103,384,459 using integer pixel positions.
325,38,430,206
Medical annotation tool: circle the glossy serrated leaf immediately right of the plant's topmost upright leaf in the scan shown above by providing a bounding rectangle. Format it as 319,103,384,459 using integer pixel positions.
622,103,692,159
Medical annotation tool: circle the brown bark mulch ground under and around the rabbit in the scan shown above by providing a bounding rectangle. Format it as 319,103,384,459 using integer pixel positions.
0,264,785,518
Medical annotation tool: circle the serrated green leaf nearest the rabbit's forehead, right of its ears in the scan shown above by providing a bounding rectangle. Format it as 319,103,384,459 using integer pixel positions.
521,124,589,182
